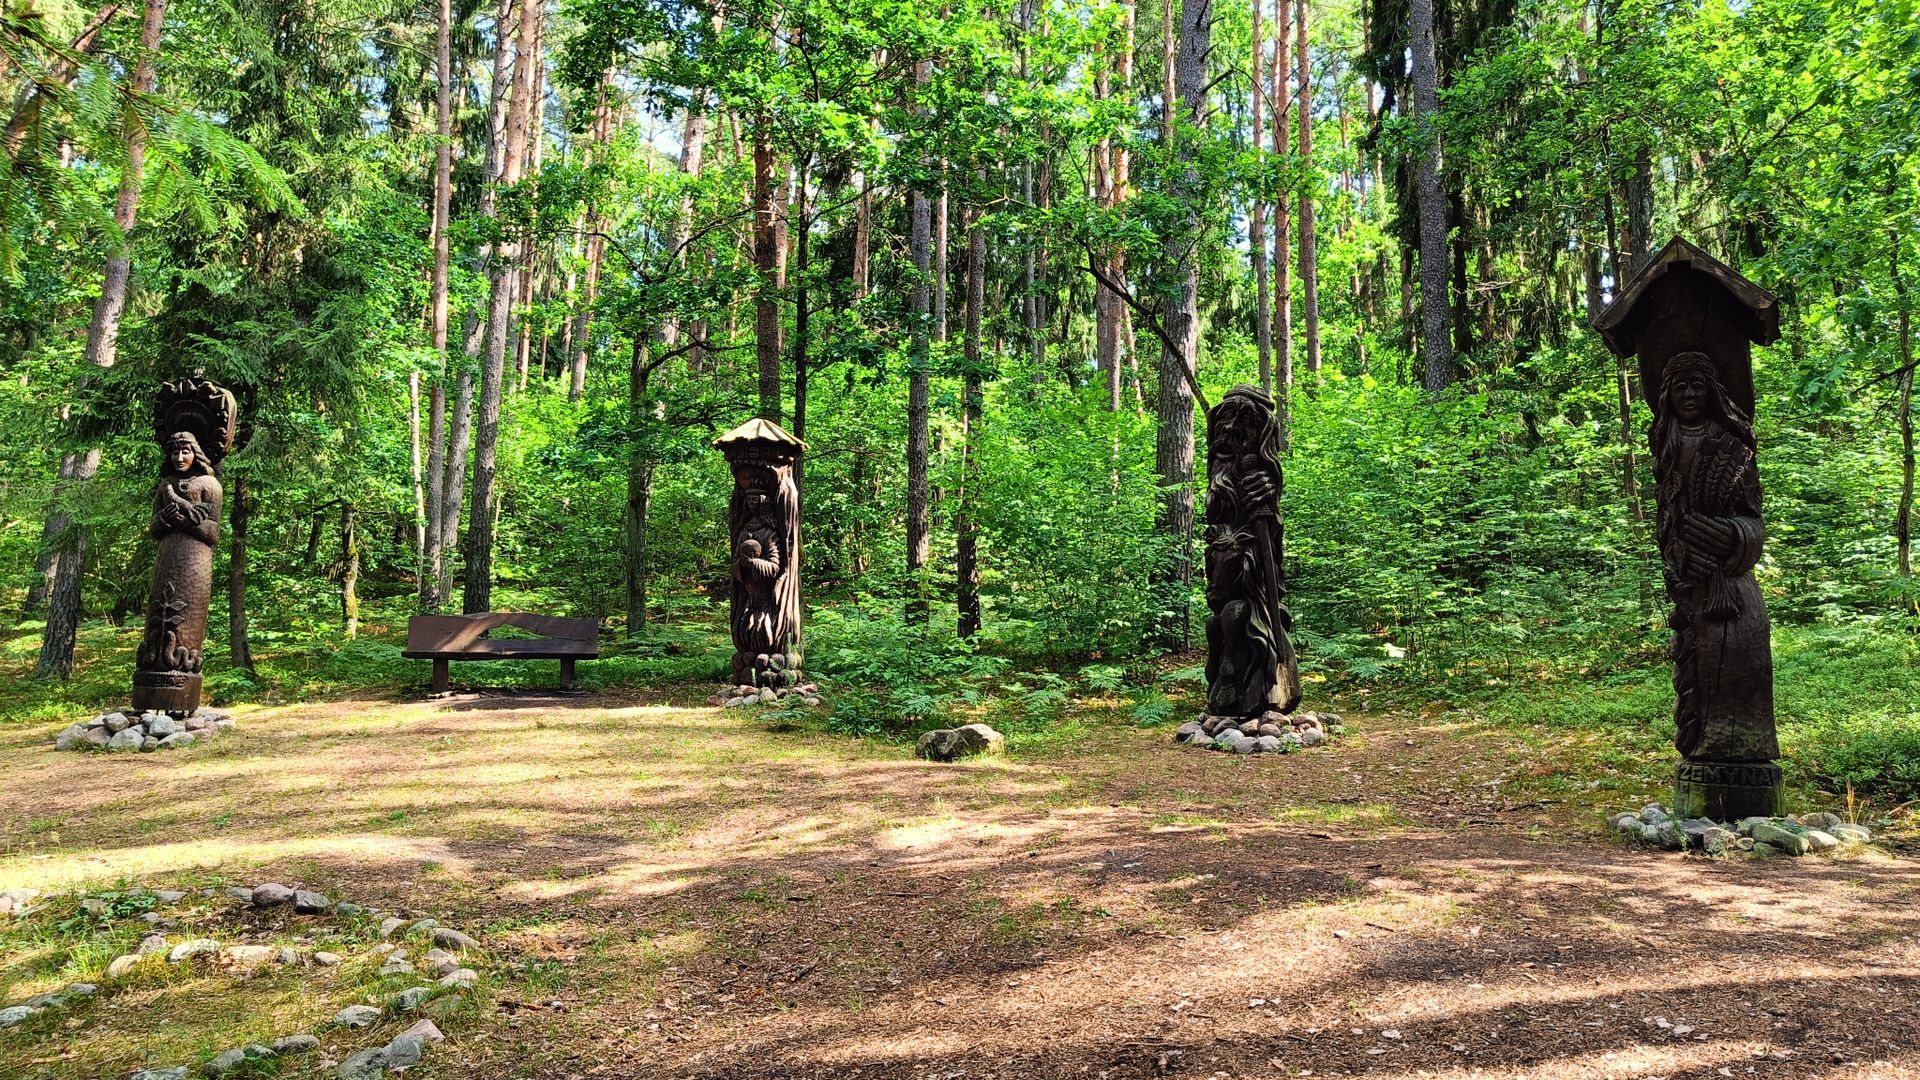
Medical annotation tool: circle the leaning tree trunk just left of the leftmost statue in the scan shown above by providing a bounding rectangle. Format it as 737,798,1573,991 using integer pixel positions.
35,0,167,678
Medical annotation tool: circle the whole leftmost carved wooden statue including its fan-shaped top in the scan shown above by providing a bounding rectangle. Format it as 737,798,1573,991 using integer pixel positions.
132,379,234,715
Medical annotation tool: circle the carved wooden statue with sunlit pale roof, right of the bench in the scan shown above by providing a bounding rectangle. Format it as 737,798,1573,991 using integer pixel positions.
714,419,806,694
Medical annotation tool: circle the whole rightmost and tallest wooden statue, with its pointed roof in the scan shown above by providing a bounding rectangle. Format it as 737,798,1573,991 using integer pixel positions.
1594,238,1782,821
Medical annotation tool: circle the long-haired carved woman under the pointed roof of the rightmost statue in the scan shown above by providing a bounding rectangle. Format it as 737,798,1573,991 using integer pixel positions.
1649,352,1780,763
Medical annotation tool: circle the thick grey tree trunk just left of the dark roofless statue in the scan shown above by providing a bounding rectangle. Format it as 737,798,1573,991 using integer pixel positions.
1154,0,1213,648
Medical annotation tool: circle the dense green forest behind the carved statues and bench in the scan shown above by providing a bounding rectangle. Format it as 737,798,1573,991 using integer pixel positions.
0,0,1920,794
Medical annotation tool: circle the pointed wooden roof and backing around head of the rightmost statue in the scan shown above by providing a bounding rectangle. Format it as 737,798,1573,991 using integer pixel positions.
1594,236,1780,415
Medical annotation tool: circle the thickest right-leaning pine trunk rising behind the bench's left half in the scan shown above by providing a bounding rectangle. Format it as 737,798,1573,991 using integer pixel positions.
461,0,541,613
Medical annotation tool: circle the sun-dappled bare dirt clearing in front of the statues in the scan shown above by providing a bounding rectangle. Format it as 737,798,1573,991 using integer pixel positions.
0,696,1920,1080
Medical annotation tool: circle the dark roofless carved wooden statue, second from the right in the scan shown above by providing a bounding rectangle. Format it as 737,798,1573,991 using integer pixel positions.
1206,384,1300,717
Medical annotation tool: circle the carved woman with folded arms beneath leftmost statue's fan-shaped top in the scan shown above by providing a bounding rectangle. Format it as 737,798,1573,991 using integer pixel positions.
134,430,223,711
